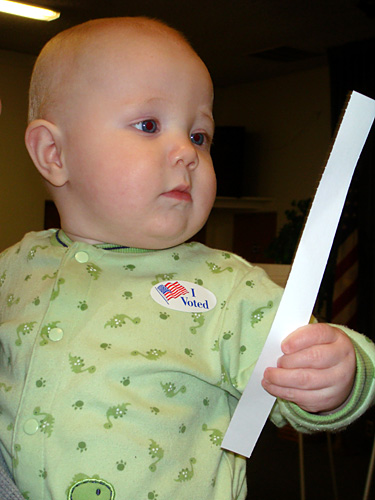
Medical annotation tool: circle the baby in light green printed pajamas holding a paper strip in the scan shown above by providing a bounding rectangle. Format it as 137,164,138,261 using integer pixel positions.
0,18,375,500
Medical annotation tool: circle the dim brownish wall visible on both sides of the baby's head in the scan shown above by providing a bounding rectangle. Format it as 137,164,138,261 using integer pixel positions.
0,47,330,250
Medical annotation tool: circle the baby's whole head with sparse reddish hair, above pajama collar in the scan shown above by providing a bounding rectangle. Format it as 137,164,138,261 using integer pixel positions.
26,18,216,249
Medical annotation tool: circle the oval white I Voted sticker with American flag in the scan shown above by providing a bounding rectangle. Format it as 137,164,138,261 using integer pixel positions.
150,281,216,312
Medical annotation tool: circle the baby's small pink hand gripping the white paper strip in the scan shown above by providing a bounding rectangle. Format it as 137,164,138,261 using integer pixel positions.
262,323,356,413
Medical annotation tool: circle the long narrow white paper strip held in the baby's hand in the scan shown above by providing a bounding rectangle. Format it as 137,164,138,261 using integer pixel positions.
222,92,375,457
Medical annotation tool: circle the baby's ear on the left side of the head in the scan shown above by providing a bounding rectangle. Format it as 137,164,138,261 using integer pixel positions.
25,119,68,187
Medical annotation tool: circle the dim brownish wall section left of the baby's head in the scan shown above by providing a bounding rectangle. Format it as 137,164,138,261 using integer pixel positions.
0,51,45,250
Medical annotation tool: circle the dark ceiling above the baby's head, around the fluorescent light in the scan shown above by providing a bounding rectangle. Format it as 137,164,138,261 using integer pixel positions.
0,0,375,86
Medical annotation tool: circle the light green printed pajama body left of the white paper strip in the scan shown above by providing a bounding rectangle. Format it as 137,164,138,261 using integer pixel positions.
0,230,334,500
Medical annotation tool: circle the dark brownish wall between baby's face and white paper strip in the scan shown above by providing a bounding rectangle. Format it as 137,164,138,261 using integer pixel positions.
215,66,331,227
